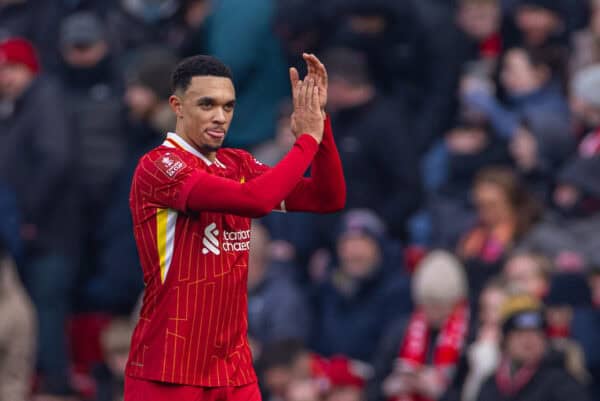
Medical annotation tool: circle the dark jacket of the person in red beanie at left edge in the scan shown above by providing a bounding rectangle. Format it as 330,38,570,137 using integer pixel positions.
0,76,77,255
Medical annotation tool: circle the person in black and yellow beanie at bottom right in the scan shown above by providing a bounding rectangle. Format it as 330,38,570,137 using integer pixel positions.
477,295,589,401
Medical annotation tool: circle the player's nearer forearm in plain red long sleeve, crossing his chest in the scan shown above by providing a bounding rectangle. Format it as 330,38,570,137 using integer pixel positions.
186,135,318,217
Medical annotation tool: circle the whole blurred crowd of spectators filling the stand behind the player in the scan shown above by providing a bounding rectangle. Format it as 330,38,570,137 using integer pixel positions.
0,0,600,401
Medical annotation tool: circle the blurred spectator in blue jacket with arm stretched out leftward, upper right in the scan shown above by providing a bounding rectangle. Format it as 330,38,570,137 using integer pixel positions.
462,48,575,197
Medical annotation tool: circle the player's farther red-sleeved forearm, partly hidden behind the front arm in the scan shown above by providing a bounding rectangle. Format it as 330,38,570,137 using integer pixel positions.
285,118,346,213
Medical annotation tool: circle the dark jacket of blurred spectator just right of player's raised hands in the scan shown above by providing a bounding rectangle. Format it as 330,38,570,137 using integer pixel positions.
332,97,422,236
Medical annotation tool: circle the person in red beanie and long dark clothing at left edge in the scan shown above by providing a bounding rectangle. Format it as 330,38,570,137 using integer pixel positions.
0,38,79,393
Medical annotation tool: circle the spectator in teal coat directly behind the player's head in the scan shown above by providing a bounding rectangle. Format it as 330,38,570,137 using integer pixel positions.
205,0,289,148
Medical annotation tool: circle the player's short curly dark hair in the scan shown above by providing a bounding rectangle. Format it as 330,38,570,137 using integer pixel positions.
171,55,233,92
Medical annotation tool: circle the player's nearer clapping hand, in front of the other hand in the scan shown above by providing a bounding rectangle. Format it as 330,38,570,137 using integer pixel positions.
290,68,324,143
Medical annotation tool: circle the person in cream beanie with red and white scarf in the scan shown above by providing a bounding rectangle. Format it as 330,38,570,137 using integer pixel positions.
369,251,469,400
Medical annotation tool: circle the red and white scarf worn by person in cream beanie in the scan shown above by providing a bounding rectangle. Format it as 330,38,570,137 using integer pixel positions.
390,301,469,401
